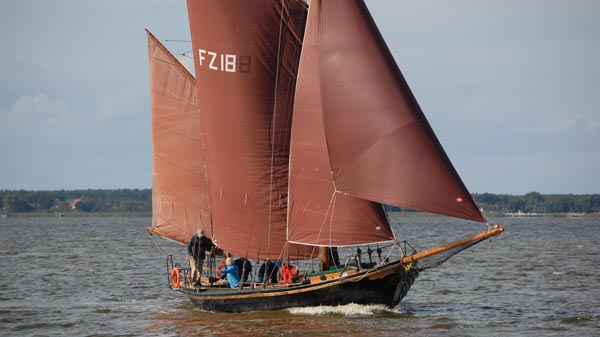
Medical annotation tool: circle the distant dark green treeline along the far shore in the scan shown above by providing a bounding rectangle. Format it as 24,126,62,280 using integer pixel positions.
0,189,600,214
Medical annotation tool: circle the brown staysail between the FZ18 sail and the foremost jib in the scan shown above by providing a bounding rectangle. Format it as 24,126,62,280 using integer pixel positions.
288,1,394,246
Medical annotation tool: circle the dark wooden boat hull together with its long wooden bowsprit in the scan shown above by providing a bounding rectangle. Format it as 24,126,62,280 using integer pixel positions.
166,227,504,312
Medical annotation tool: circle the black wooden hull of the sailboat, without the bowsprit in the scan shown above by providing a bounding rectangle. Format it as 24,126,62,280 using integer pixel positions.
182,264,418,312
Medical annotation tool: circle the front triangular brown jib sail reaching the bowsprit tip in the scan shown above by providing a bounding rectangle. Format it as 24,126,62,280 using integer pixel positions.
304,0,486,222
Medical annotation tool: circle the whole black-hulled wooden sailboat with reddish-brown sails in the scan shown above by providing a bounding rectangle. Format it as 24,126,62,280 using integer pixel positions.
147,0,503,312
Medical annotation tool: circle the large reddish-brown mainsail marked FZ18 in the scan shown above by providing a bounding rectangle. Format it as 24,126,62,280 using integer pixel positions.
187,0,306,258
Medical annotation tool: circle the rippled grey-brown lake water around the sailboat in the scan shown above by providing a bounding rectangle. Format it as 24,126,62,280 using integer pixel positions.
0,217,600,336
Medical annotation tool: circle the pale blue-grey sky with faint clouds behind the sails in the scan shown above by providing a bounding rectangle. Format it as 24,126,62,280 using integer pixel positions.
0,0,600,195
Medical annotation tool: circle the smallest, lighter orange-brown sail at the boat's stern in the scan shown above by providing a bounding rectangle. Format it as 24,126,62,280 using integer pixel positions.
147,31,210,243
